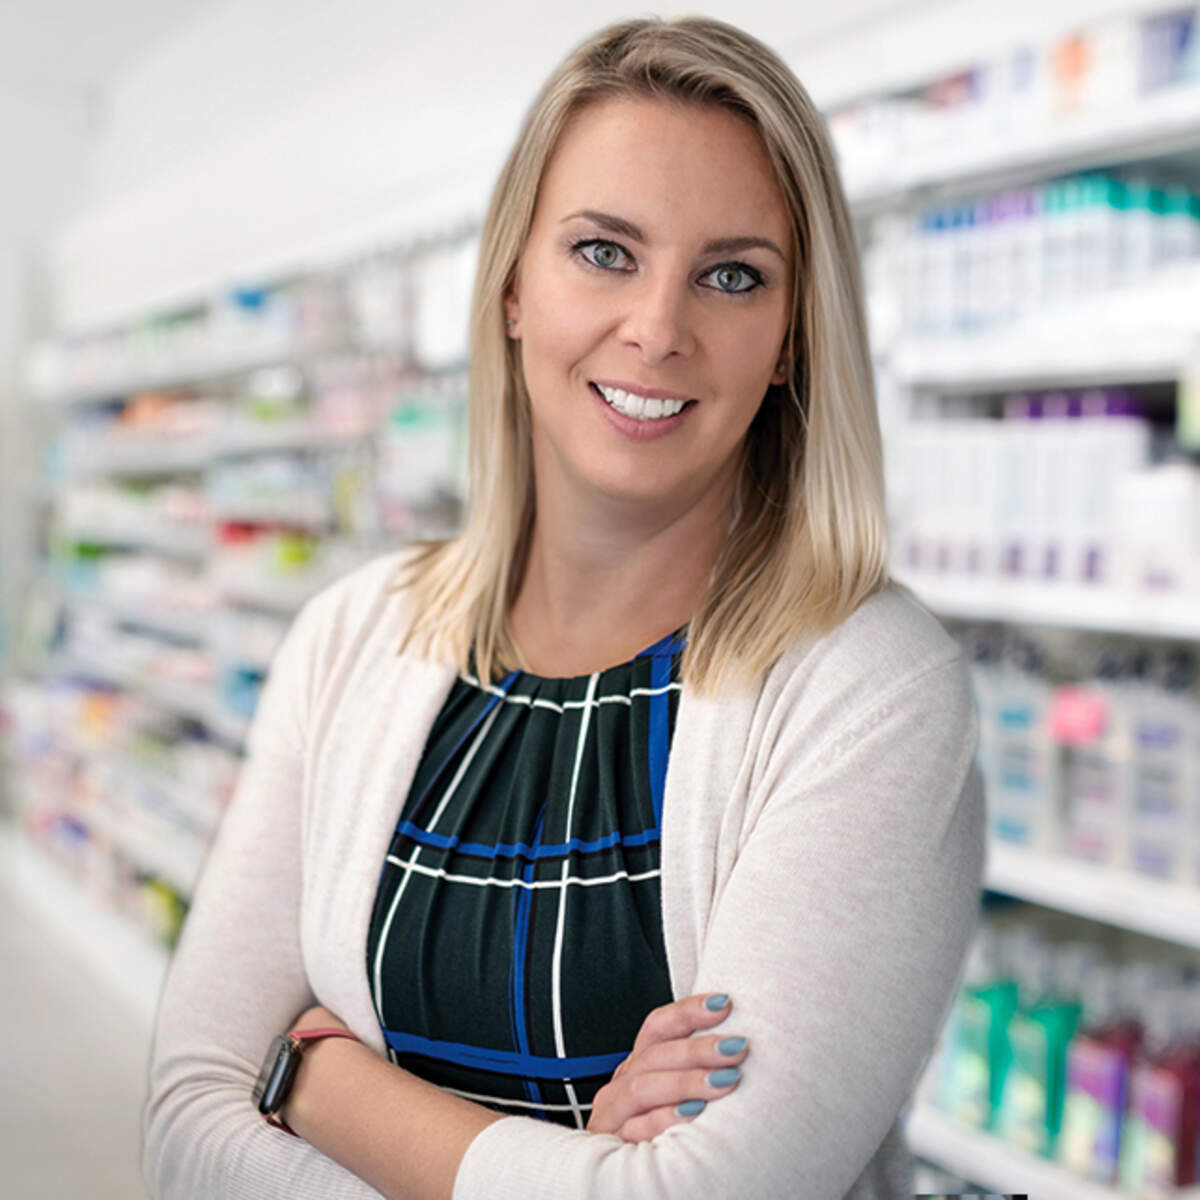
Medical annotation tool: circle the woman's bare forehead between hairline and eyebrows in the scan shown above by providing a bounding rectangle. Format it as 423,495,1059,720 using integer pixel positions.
538,98,788,239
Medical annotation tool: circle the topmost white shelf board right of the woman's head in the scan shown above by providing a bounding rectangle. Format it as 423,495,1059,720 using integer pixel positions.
846,86,1200,216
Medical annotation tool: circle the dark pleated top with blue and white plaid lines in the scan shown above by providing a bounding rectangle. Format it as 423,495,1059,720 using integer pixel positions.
367,630,684,1128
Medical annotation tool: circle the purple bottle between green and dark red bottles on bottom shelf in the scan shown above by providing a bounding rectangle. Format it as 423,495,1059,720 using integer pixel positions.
1058,964,1141,1183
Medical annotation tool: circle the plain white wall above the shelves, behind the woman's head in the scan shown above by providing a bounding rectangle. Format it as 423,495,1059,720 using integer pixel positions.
54,0,1164,331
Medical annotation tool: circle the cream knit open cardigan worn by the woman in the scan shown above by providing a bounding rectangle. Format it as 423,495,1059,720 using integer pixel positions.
144,552,984,1200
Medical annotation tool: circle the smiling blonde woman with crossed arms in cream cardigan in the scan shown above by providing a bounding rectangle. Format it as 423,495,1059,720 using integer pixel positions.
145,11,983,1200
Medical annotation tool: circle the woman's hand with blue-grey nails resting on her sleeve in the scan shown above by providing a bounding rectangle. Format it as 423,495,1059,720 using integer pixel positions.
588,994,750,1141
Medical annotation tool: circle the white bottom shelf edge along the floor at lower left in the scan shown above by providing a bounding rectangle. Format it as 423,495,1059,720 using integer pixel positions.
0,821,168,1033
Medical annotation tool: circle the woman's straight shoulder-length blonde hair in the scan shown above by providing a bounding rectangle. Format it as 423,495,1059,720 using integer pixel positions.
400,17,888,691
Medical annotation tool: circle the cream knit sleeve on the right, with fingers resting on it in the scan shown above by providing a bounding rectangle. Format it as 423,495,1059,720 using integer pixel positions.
454,656,985,1200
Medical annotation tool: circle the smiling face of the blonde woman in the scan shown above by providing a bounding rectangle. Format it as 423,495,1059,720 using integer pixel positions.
506,100,792,510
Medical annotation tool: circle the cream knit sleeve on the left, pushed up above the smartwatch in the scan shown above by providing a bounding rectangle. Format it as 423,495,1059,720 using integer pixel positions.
143,596,378,1200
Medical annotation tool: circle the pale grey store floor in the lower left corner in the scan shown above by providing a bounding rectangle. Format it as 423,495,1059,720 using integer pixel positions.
0,887,150,1200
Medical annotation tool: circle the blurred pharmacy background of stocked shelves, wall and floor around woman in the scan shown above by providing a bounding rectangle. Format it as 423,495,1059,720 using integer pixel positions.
0,0,1200,1200
